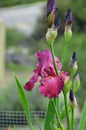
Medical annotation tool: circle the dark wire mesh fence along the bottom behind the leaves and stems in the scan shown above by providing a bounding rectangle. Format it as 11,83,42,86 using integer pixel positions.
0,111,86,130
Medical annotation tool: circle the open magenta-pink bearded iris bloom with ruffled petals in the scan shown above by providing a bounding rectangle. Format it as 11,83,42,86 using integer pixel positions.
24,49,64,98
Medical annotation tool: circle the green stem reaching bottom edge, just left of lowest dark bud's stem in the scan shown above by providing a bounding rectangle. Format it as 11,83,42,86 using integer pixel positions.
63,92,70,130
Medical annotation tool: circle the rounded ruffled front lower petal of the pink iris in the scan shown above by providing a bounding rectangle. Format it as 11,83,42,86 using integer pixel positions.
39,76,64,98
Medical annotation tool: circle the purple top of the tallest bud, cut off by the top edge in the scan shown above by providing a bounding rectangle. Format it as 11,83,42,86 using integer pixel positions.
46,0,57,16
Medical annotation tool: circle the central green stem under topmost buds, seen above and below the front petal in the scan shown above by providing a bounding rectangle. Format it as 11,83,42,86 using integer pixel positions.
50,44,60,115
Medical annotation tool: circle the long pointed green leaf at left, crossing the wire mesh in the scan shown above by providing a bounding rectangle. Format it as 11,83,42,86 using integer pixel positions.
15,76,34,130
